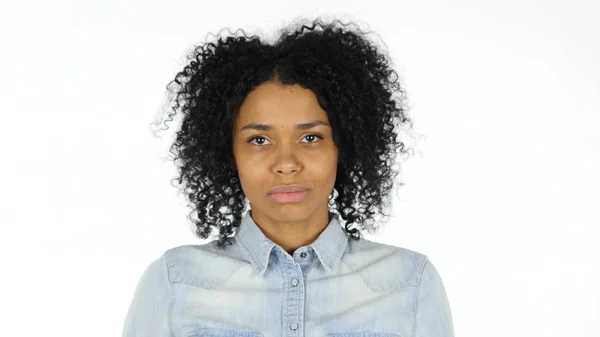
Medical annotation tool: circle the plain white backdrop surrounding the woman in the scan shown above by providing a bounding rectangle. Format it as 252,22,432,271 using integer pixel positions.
0,0,600,337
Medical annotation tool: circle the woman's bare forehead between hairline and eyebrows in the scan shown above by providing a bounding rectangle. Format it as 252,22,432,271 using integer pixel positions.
237,82,327,124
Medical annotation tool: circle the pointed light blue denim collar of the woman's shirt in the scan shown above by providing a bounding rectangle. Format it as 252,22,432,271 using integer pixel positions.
235,211,348,277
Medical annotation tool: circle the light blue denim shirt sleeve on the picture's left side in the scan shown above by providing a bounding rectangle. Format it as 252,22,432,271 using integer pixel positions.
123,254,171,337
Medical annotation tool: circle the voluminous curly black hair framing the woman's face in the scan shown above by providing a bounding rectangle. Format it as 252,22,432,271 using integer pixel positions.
150,18,413,248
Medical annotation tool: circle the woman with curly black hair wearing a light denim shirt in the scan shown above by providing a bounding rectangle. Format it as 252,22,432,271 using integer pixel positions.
123,20,453,337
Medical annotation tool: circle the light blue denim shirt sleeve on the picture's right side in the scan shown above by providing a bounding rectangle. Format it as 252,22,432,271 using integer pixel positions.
414,258,454,337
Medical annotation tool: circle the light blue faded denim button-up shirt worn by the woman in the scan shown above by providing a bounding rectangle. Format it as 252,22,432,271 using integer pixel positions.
123,211,454,337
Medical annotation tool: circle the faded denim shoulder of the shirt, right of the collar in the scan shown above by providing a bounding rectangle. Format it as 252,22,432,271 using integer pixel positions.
342,237,428,292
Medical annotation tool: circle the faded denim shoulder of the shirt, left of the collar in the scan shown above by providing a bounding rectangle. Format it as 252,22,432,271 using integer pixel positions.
164,241,244,289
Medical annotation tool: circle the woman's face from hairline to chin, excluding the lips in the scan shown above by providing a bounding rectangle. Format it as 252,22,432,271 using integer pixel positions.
233,82,338,222
